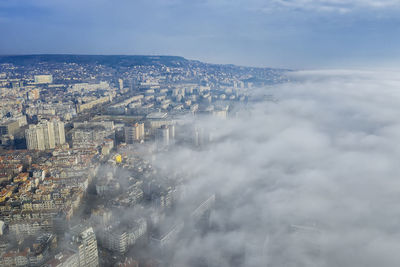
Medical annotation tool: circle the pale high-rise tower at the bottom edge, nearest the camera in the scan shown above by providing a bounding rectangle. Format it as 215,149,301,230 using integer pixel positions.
71,225,99,267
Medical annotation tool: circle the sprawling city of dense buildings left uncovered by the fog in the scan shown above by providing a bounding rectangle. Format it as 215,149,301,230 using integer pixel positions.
0,55,288,266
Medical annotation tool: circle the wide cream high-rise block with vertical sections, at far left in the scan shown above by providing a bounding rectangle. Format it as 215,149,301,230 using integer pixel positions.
25,119,65,150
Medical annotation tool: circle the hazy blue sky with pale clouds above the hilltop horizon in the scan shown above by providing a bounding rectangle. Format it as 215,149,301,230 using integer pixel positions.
0,0,400,69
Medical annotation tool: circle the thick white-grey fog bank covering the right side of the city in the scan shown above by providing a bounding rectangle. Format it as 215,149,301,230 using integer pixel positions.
150,70,400,266
